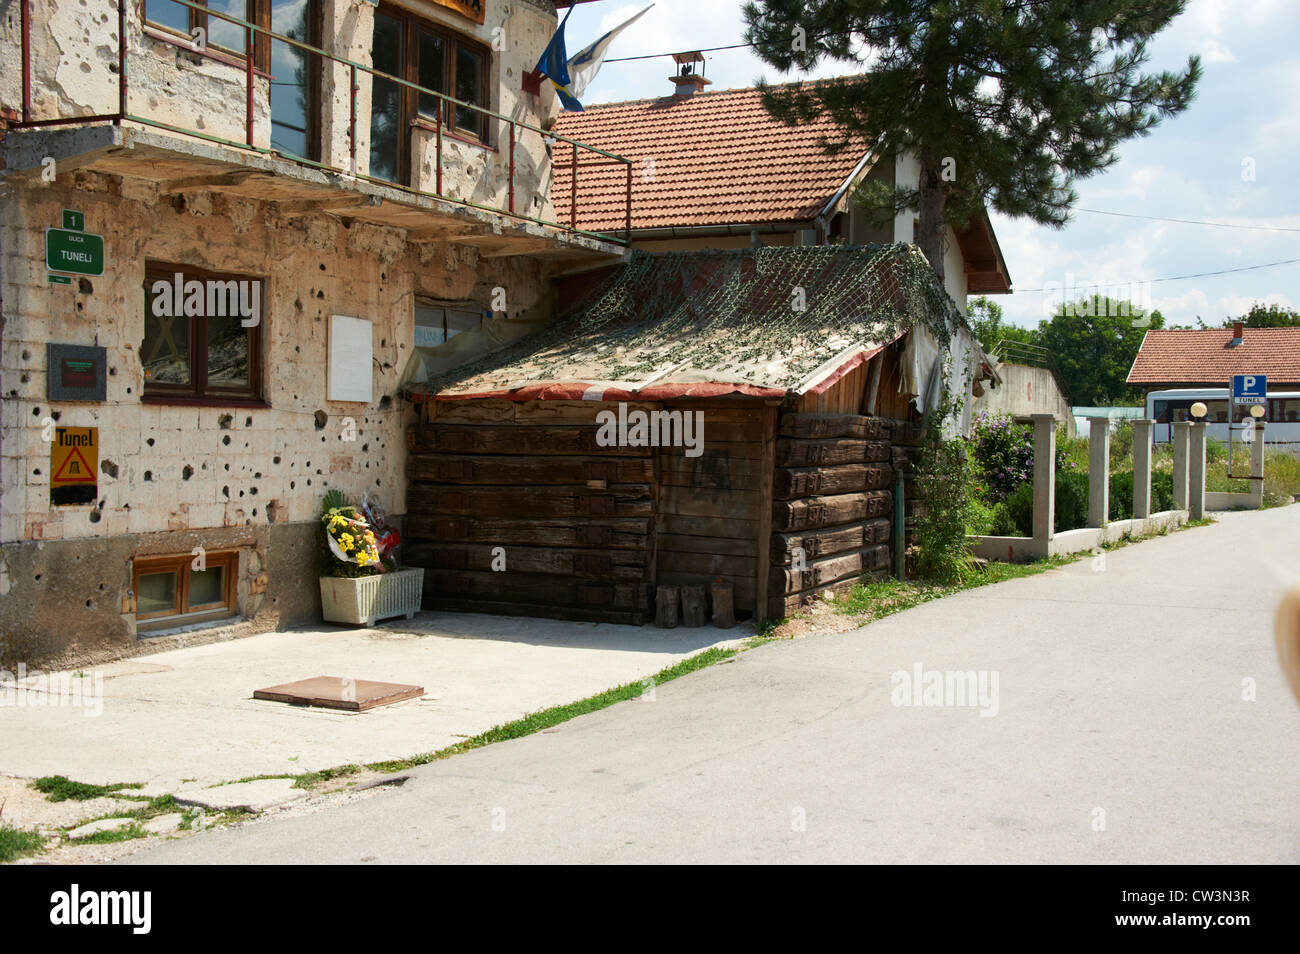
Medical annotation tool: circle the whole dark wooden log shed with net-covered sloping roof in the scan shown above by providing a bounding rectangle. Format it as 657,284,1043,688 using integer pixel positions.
404,246,993,624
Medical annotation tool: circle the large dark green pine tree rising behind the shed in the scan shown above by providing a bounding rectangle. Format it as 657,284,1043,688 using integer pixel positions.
744,0,1201,278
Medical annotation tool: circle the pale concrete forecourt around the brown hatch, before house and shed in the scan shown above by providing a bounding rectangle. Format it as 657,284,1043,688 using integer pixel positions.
0,613,749,793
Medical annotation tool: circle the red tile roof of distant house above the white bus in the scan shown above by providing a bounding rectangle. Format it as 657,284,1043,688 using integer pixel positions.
1128,328,1300,389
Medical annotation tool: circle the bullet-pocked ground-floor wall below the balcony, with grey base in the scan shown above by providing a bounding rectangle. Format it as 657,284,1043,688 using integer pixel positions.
0,167,549,664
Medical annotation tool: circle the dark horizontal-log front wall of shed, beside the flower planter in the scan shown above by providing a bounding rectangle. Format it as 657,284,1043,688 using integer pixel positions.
404,400,655,624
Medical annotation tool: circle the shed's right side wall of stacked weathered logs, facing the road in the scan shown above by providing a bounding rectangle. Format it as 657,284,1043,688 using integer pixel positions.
767,412,901,619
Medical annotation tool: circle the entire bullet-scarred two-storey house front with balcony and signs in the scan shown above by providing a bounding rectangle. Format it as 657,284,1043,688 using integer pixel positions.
0,0,627,665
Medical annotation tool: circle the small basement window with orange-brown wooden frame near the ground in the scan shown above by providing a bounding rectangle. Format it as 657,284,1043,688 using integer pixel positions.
131,550,239,630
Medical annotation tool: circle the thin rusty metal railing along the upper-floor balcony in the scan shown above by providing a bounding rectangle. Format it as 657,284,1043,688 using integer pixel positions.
13,0,632,244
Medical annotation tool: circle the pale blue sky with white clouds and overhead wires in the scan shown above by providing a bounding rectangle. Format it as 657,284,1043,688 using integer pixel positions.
566,0,1300,326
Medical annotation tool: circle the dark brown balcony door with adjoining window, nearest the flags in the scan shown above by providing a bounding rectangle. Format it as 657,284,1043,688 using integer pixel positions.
371,4,491,185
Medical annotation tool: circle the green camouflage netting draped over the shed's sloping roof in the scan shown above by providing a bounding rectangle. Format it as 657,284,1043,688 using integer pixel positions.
421,244,963,396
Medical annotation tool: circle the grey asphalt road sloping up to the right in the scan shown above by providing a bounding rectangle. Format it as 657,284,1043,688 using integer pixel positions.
130,506,1300,863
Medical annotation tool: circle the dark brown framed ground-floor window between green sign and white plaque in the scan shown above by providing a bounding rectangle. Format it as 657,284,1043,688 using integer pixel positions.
140,263,267,407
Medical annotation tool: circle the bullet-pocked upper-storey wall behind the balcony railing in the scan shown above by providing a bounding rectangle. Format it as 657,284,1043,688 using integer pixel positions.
0,0,564,221
